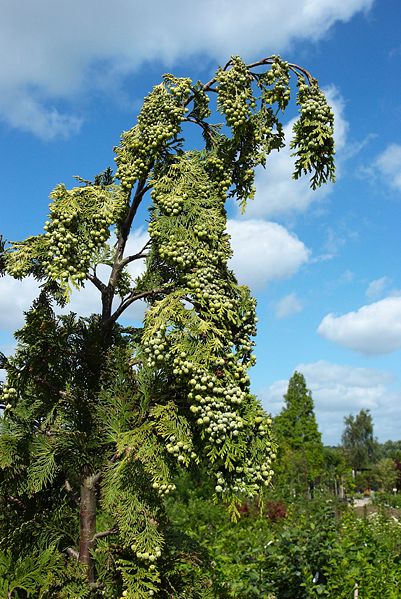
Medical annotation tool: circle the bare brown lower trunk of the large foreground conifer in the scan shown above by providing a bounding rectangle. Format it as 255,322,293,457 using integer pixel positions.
79,475,96,583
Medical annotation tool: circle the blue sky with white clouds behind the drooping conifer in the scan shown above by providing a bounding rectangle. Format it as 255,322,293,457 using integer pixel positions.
0,0,401,444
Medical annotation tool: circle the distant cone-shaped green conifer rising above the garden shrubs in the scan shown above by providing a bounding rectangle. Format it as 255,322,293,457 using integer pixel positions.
274,371,324,492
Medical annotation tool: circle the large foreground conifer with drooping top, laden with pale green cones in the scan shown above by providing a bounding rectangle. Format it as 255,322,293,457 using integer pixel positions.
0,56,334,599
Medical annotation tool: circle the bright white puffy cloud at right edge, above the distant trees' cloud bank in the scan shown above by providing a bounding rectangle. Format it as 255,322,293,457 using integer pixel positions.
318,297,401,355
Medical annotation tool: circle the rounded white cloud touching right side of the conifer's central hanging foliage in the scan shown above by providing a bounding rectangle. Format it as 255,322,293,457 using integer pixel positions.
227,219,310,288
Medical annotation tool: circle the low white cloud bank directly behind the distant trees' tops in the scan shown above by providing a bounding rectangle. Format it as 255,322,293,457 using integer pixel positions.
260,360,401,444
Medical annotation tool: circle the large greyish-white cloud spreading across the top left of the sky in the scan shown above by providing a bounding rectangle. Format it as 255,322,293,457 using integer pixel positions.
0,0,373,138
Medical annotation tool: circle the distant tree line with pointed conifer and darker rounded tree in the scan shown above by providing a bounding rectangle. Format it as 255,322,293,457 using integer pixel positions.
273,372,401,498
